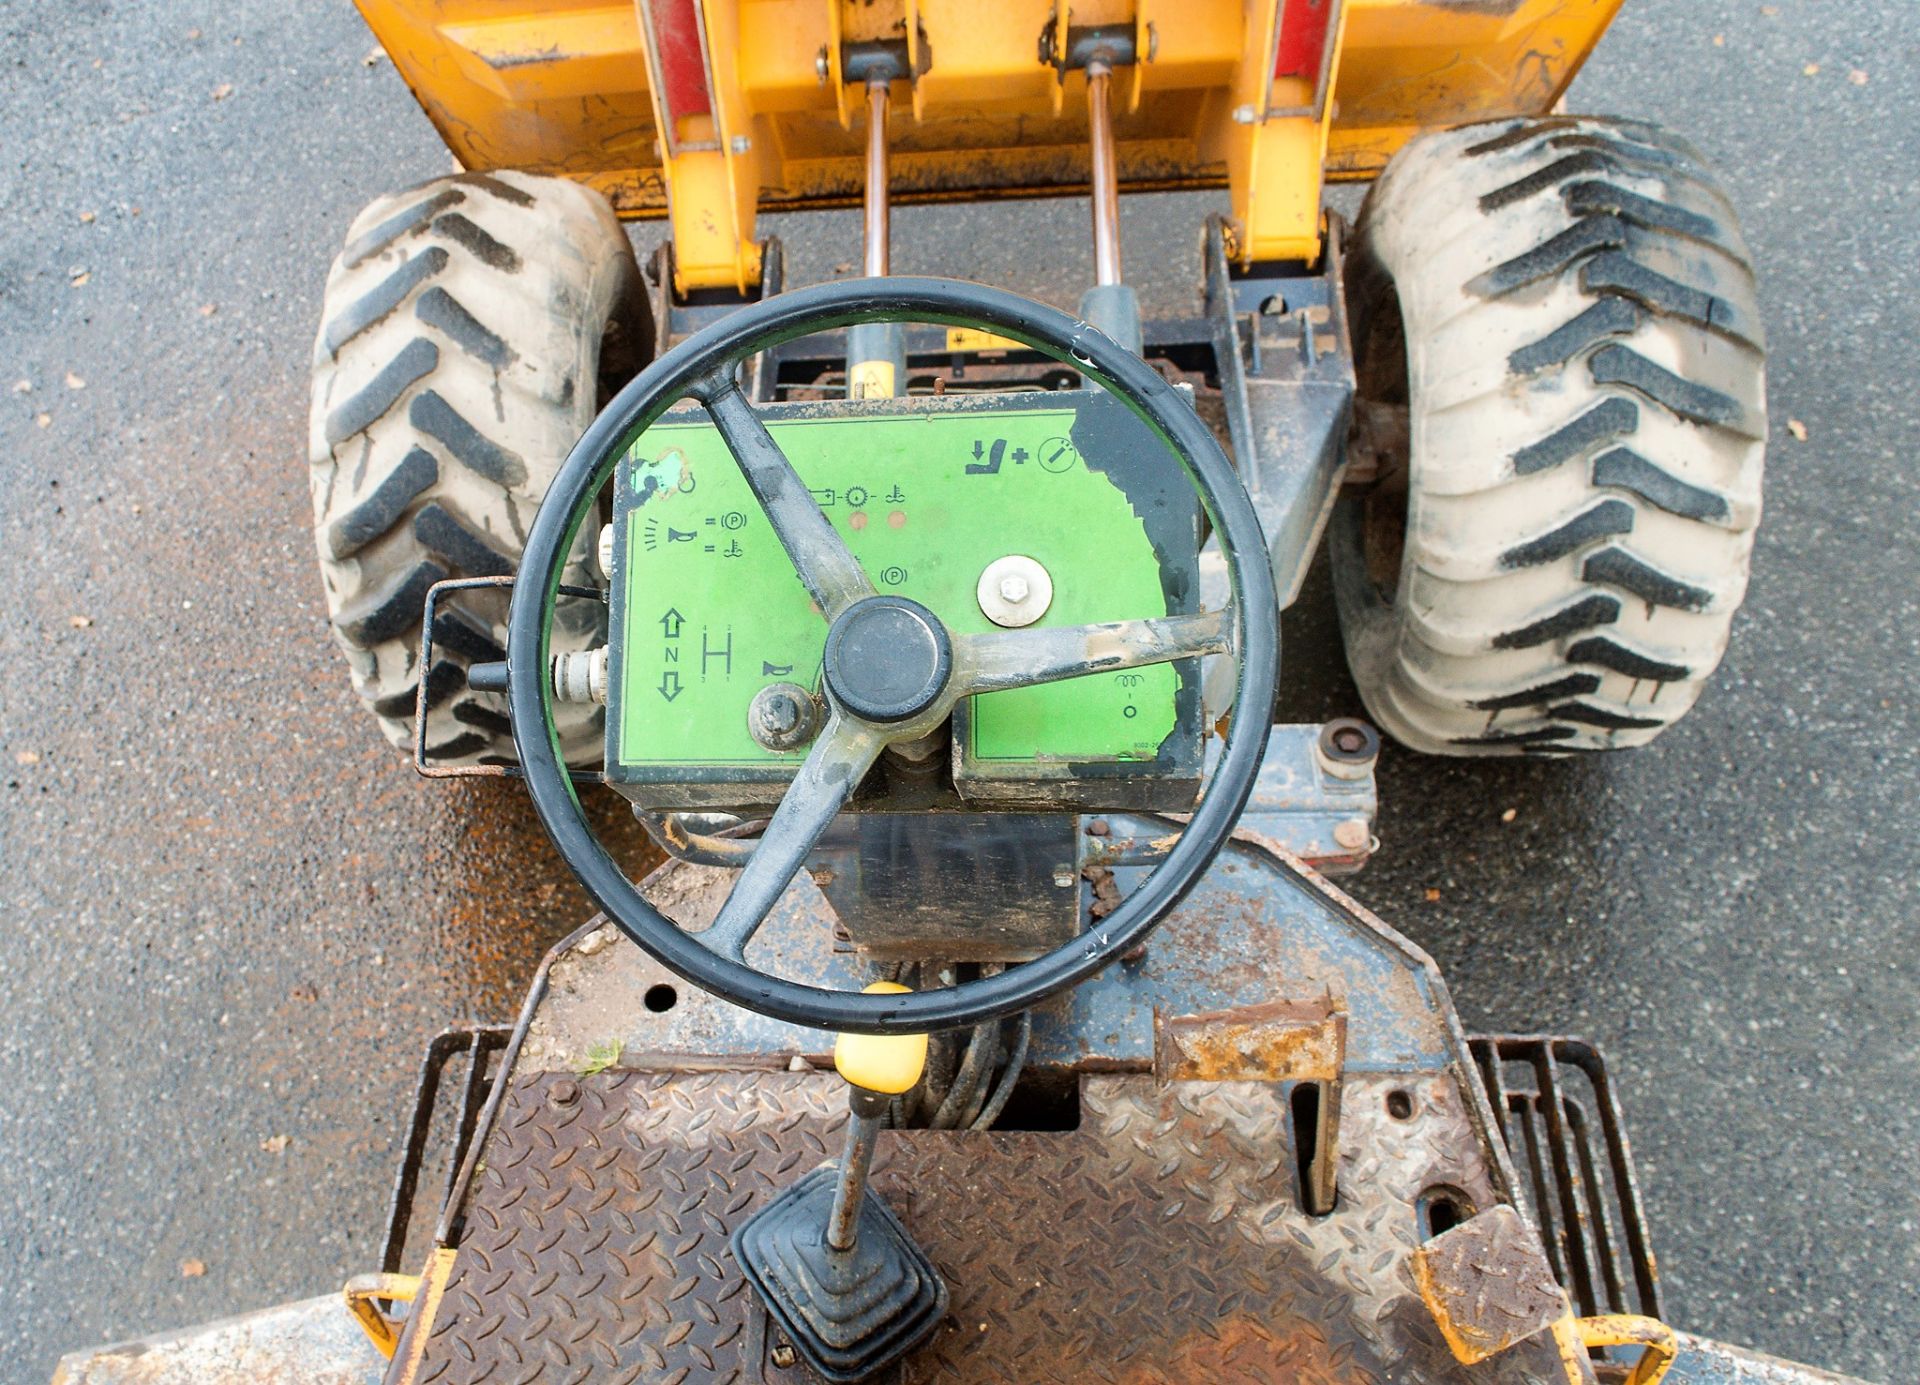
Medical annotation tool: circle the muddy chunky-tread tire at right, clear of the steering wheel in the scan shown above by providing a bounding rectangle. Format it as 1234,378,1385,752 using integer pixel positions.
1331,117,1766,755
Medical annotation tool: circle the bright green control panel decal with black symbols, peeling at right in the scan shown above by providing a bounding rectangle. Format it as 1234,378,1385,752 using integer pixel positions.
614,409,1181,768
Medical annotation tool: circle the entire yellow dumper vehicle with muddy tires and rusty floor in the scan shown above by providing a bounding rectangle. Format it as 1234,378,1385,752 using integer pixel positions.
60,0,1834,1385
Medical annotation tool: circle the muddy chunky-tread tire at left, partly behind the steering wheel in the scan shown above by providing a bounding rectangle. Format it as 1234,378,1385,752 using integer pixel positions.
307,173,653,765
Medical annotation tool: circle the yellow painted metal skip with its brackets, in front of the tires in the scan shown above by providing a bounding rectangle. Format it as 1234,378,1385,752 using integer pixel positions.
357,0,1620,292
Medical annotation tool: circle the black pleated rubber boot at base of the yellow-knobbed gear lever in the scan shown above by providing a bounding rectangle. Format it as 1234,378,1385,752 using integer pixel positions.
733,1164,947,1383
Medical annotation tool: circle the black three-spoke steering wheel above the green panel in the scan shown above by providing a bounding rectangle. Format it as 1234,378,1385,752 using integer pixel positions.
507,279,1279,1033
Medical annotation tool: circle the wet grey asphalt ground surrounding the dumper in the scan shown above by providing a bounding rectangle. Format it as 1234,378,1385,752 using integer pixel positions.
0,0,1920,1381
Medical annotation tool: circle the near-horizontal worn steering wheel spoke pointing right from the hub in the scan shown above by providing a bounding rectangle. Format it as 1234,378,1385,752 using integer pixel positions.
954,607,1233,697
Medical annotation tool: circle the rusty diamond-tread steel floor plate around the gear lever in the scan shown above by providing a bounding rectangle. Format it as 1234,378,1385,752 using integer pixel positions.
390,1070,1565,1385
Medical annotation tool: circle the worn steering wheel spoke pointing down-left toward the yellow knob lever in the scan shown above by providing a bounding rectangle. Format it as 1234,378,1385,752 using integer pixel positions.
699,715,887,962
